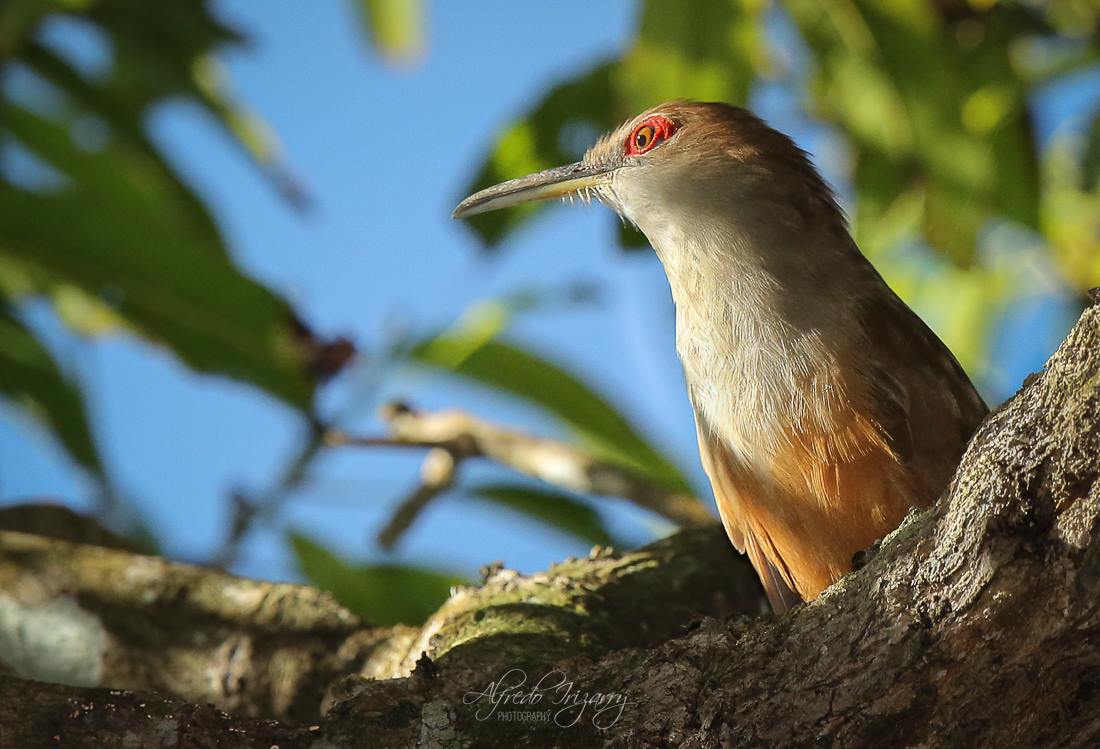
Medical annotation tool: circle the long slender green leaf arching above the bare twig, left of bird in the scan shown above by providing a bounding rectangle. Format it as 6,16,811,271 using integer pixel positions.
409,327,689,491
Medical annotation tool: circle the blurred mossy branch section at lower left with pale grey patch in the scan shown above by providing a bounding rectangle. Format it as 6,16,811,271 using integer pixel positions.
0,531,374,721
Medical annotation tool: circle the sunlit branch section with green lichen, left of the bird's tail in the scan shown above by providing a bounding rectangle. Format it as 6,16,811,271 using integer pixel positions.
354,524,766,679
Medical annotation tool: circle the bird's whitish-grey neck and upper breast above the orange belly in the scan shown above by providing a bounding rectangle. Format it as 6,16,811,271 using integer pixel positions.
637,192,866,444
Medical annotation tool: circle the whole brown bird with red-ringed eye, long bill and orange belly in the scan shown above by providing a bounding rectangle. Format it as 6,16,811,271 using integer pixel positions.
453,101,988,613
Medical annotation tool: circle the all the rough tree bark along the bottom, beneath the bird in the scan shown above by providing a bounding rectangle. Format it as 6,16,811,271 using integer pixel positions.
0,299,1100,748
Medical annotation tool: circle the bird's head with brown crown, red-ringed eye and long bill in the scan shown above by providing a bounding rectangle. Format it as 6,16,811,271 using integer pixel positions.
454,101,844,246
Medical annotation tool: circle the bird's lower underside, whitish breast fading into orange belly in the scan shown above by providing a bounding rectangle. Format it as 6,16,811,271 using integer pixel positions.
677,305,913,598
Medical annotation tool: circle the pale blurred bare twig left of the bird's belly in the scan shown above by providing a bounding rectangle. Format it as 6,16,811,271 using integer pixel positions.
326,404,714,540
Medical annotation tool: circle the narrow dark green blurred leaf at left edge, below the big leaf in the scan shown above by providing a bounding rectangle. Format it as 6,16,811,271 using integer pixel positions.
0,299,103,470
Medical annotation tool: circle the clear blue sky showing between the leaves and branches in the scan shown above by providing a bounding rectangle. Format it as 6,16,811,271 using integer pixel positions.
0,0,1086,579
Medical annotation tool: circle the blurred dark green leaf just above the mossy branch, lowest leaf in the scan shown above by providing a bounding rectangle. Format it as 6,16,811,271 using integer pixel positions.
289,533,470,627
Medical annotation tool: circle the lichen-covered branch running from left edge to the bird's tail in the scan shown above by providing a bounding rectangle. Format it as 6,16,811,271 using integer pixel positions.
0,507,765,721
